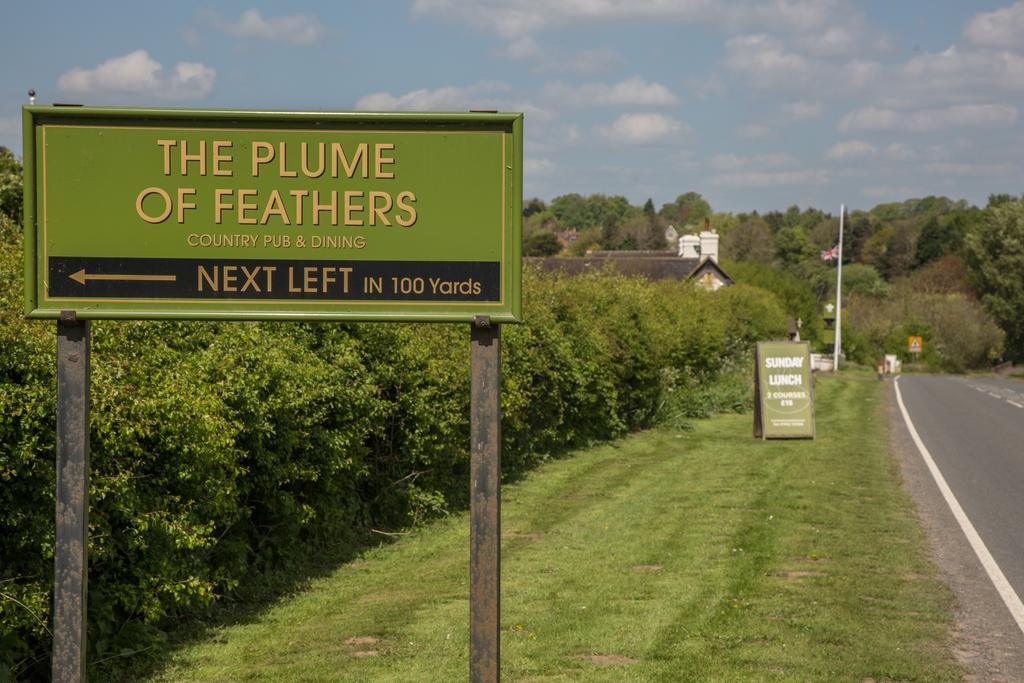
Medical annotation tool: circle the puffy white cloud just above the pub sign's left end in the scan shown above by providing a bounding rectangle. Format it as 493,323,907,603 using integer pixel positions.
57,50,217,100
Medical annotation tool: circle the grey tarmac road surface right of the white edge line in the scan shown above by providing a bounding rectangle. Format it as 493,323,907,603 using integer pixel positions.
898,375,1024,628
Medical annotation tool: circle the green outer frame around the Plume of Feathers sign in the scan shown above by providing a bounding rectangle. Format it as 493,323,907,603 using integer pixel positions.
23,105,522,324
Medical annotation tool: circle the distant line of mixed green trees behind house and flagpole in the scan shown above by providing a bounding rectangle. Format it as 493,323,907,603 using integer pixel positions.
523,187,1024,370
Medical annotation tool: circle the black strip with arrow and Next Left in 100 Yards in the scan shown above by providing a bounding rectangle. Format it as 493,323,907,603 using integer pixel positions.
48,256,501,302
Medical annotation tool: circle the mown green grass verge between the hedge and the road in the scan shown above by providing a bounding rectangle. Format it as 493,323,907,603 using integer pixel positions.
149,380,963,681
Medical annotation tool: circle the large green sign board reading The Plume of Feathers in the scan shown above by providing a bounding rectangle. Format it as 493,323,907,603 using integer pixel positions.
24,106,522,323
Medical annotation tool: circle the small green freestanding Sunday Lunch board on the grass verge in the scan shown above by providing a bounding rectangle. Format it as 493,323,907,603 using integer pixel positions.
754,342,814,438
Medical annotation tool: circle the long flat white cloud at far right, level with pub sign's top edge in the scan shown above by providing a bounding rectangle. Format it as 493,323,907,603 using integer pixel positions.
838,104,1018,133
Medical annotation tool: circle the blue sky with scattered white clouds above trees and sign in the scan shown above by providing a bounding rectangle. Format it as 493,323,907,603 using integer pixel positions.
0,0,1024,213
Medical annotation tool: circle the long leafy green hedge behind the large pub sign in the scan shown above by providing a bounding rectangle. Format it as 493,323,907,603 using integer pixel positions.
0,218,784,678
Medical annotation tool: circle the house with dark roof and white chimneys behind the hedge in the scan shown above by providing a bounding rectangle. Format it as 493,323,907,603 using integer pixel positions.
523,224,732,292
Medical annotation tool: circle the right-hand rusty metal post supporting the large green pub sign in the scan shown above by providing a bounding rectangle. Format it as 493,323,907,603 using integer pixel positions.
469,318,502,683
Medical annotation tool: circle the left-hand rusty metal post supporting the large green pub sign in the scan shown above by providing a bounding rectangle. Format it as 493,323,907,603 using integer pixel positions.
53,312,90,683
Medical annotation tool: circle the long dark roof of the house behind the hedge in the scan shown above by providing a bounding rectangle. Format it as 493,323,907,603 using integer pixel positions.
523,251,733,285
